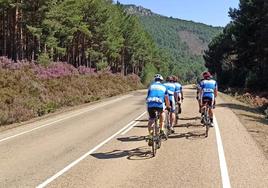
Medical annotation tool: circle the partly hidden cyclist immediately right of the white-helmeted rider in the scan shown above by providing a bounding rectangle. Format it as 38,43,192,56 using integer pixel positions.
164,76,176,133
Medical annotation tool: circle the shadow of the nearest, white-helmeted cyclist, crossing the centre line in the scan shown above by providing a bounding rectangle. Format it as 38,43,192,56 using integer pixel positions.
91,147,152,160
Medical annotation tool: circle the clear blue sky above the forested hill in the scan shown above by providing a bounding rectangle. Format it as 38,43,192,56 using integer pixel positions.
119,0,239,26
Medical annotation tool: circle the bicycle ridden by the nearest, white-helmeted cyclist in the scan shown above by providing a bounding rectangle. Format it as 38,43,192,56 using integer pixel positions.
149,111,162,157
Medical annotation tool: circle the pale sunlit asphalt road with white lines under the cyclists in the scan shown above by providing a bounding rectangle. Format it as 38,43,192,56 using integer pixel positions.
0,87,268,188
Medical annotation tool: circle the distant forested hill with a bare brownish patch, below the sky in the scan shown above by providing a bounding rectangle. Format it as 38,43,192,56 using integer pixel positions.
124,5,222,81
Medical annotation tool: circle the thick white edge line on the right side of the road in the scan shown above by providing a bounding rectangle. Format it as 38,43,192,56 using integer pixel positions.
214,115,231,188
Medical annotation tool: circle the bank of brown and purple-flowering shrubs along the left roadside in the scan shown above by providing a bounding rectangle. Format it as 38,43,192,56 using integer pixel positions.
0,57,142,125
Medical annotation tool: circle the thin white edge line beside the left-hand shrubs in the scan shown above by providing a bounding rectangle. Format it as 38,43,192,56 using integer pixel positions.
0,95,129,143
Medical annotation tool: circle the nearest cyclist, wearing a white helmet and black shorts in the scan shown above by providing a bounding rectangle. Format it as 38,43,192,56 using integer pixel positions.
146,74,169,146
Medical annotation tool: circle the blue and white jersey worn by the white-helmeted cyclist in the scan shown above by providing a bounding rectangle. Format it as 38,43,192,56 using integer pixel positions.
146,82,168,108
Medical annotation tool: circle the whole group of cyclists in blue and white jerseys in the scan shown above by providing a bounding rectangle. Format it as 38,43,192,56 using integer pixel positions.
146,72,218,146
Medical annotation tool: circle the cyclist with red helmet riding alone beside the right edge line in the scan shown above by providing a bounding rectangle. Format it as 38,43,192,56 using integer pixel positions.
200,72,218,127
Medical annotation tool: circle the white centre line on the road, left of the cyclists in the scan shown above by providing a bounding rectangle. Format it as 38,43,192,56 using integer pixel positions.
36,112,146,188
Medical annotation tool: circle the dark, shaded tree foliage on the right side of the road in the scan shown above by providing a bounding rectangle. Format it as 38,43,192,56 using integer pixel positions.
204,0,268,91
